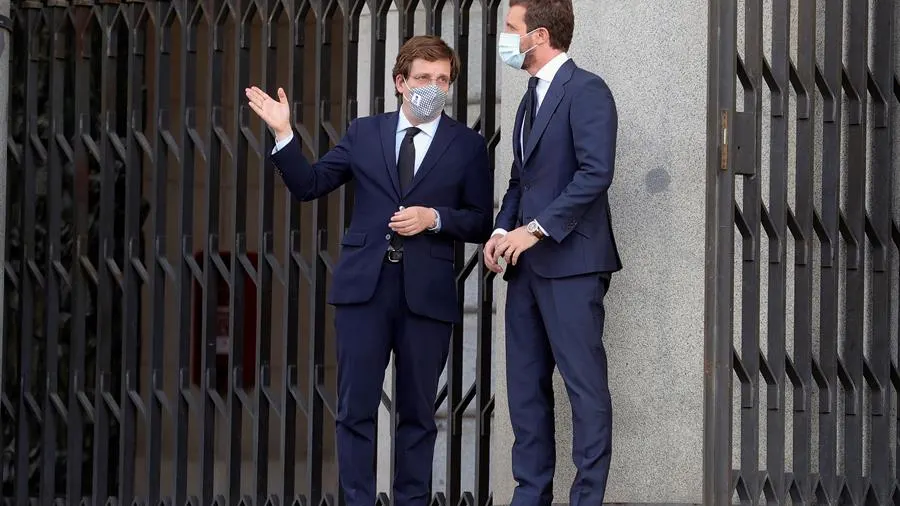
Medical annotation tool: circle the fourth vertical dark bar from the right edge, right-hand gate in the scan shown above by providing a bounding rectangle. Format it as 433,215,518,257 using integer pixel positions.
792,0,816,497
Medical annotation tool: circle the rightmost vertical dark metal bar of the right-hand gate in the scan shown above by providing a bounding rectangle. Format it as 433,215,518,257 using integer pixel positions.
868,0,896,503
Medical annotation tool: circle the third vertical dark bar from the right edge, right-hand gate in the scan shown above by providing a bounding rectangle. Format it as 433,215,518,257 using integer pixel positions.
819,0,844,497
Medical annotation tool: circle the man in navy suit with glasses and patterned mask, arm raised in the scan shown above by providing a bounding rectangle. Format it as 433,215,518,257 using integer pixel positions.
247,36,493,506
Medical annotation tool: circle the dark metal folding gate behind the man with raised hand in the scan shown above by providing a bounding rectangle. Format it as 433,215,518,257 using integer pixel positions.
0,0,499,506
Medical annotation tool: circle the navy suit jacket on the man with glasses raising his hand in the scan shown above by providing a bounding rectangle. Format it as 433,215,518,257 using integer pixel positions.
272,112,494,322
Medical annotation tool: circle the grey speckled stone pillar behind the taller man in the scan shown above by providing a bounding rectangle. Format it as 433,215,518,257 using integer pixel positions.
492,0,707,504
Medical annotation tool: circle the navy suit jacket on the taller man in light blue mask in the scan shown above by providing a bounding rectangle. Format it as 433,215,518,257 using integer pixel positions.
496,60,622,278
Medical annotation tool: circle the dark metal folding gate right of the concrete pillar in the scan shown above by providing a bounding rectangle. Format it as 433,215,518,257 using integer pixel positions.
704,0,900,505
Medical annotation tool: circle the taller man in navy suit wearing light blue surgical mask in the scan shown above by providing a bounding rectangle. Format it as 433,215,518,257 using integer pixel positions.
484,0,622,506
